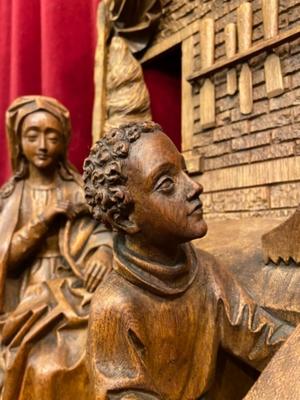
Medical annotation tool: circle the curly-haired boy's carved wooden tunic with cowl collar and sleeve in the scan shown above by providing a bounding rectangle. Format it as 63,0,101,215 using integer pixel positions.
88,235,293,400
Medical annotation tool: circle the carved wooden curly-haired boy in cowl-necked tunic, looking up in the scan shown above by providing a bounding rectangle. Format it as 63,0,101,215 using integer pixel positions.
84,122,293,400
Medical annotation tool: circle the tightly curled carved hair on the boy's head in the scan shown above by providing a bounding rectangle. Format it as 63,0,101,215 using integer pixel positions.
83,121,162,227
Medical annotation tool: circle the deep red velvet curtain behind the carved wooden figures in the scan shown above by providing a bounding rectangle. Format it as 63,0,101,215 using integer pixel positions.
0,0,180,184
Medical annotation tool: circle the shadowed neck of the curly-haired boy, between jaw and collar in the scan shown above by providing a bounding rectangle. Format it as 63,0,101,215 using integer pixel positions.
125,235,182,266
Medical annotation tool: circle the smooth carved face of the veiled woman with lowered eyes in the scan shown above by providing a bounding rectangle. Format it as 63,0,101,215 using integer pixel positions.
21,111,65,169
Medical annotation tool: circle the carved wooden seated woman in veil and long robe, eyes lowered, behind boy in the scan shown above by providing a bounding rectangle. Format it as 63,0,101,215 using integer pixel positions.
0,96,112,400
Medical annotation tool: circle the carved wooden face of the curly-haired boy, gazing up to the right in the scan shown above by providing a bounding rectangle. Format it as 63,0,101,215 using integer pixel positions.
126,132,207,244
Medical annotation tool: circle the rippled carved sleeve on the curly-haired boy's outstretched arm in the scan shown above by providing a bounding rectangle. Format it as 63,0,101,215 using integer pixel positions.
203,252,294,370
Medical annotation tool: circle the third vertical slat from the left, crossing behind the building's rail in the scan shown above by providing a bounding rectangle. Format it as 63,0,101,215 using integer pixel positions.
238,2,253,114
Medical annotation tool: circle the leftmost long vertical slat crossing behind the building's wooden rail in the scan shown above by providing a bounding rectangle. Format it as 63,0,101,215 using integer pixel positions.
200,18,216,129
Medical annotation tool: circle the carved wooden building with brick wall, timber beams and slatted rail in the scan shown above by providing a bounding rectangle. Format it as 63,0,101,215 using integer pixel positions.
140,0,300,219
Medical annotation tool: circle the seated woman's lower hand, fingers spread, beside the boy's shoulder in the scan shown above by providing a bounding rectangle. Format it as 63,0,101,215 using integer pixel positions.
84,246,112,292
